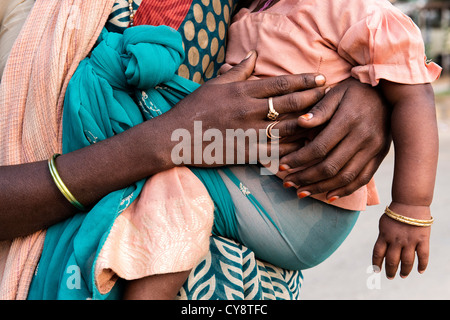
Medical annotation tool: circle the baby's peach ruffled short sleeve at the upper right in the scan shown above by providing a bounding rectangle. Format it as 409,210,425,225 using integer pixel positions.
338,3,441,86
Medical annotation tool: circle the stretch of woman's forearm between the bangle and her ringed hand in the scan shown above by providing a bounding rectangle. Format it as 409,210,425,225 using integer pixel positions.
53,121,178,206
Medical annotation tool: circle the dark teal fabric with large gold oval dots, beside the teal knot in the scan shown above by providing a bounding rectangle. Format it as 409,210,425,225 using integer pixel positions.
178,0,241,83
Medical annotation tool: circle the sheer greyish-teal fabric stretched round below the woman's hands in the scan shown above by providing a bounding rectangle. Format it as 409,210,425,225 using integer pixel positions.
219,166,359,270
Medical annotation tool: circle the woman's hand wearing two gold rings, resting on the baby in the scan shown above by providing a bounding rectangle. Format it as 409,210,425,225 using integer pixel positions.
162,52,326,166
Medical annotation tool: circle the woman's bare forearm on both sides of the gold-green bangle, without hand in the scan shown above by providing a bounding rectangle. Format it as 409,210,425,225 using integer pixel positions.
0,117,174,240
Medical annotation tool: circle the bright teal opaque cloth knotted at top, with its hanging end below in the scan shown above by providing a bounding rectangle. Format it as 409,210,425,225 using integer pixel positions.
28,26,251,299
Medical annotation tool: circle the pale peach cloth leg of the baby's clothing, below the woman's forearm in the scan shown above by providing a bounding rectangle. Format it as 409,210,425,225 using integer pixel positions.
95,167,214,294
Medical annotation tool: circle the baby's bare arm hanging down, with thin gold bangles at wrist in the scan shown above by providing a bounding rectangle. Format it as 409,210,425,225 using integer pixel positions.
373,81,439,278
